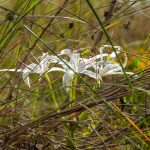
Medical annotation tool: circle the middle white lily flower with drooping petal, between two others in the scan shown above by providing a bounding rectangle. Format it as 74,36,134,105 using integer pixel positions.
59,49,100,92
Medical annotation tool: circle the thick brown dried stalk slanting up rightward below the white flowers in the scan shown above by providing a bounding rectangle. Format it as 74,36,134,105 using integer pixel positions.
1,70,150,148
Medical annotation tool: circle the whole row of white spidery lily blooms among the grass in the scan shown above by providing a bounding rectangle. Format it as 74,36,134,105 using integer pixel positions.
0,45,133,92
